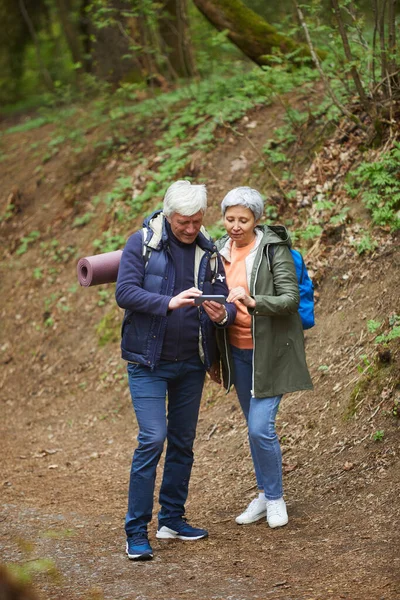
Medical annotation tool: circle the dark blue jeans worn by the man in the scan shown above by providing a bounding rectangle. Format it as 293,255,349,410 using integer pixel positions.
125,356,205,536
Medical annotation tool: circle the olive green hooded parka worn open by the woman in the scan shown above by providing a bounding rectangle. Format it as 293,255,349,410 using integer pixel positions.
216,225,313,398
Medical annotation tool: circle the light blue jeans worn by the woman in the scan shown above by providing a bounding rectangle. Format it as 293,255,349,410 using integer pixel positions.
231,346,283,500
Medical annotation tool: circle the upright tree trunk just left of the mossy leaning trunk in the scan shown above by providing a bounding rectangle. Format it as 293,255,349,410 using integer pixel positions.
159,0,196,77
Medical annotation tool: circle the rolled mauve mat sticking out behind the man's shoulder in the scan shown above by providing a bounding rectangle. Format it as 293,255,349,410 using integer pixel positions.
76,250,122,287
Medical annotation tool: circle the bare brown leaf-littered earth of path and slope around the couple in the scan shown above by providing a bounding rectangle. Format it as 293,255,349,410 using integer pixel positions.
0,88,400,600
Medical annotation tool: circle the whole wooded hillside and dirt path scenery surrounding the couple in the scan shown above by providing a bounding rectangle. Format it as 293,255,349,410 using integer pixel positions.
0,0,400,600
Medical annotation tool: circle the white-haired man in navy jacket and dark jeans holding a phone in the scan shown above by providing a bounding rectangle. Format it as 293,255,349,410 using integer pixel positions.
116,181,236,560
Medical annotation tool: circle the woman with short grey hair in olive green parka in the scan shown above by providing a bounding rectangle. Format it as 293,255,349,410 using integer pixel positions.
214,187,312,527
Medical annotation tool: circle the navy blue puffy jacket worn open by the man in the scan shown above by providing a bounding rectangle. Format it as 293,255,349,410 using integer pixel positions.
116,211,236,369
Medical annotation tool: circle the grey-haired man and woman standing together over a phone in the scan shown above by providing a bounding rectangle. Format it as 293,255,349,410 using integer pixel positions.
116,181,312,560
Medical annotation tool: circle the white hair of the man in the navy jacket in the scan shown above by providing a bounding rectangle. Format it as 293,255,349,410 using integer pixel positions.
163,179,207,217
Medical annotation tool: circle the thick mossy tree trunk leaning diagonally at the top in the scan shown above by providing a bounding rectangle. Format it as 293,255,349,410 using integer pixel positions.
193,0,310,65
